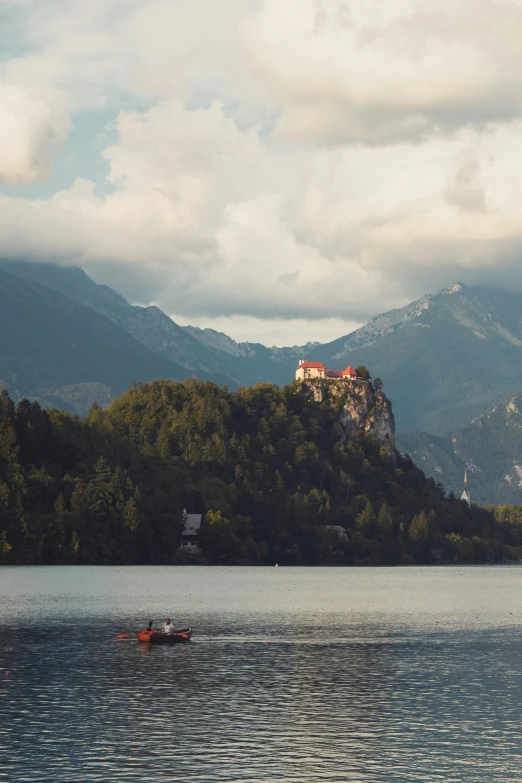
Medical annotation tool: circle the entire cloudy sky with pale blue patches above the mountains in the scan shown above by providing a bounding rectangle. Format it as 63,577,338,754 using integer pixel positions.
0,0,522,345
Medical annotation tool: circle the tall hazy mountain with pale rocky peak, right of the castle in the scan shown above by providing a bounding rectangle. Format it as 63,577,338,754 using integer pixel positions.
309,284,522,435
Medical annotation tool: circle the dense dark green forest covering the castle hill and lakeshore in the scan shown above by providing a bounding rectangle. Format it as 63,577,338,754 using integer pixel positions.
0,379,522,564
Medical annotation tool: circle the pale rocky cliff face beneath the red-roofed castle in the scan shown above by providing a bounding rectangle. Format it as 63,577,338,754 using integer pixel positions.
301,379,395,457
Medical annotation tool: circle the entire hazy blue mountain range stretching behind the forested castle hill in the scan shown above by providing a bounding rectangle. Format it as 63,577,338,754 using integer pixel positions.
0,260,522,502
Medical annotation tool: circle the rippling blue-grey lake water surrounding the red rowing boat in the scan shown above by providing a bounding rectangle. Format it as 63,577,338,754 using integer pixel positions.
0,567,522,783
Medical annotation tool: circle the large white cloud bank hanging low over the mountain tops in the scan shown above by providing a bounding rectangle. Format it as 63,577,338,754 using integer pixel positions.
0,101,522,328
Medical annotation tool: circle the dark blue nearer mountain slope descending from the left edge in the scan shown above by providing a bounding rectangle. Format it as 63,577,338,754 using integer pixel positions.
0,270,191,414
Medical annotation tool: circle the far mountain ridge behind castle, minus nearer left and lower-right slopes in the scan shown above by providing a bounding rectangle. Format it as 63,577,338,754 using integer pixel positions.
5,261,522,438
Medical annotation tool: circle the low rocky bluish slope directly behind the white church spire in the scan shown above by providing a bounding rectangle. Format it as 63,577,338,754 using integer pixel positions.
398,392,522,504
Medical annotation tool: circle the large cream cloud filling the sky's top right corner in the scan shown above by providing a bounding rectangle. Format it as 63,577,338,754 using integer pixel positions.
242,0,522,145
